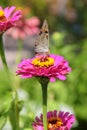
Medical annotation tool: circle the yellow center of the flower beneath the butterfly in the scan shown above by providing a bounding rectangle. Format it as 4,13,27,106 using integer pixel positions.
32,56,54,67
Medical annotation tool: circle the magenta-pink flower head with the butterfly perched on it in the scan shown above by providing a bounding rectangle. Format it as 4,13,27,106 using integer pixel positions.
16,54,71,82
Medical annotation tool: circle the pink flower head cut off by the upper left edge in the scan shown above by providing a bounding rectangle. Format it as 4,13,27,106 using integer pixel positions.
0,6,21,33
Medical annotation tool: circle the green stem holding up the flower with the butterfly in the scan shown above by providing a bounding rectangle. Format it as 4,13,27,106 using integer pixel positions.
41,80,48,130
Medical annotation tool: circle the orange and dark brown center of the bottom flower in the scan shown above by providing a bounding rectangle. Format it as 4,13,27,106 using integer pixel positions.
48,117,63,130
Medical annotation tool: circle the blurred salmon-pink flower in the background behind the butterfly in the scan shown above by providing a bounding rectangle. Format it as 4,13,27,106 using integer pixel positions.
7,16,40,39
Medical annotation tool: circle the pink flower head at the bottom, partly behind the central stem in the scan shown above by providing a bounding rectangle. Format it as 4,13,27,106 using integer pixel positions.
32,110,75,130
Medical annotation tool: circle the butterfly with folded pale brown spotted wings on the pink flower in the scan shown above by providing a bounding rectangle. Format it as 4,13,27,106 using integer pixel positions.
35,20,49,55
